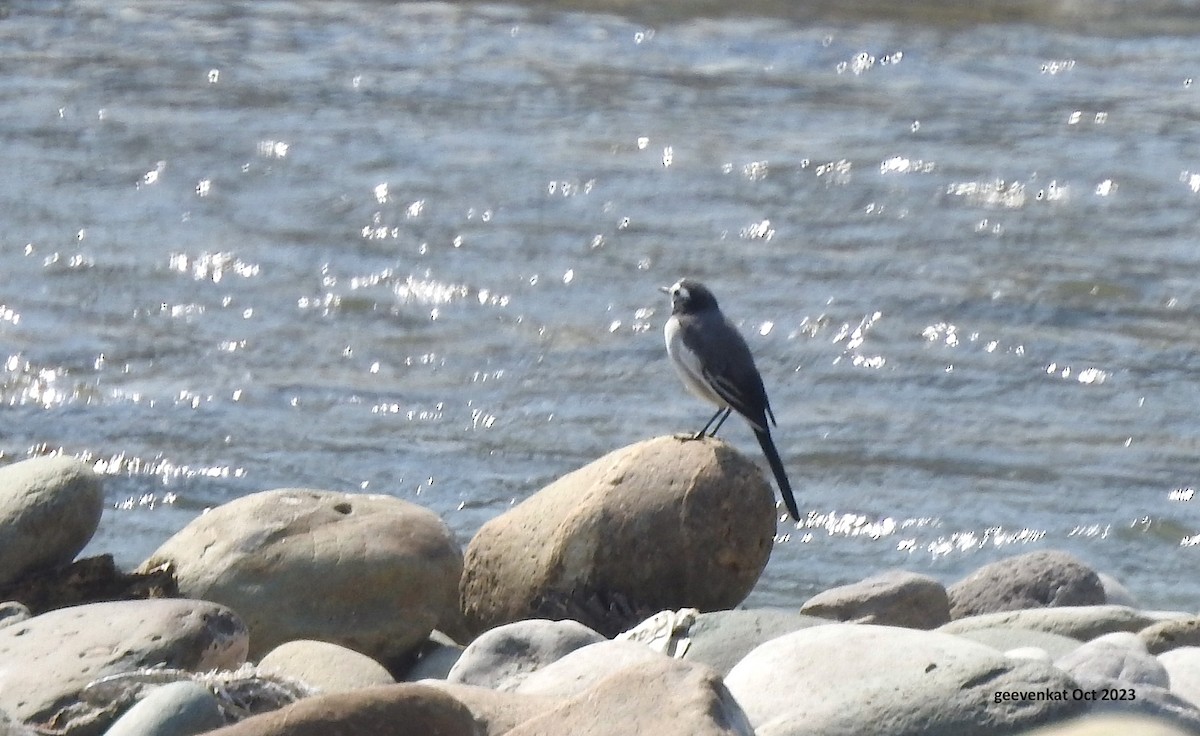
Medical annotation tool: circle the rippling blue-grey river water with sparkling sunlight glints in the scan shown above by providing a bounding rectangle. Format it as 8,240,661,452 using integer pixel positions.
0,0,1200,609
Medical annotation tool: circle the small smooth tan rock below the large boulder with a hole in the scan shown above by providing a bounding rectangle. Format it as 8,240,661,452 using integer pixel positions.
258,639,396,693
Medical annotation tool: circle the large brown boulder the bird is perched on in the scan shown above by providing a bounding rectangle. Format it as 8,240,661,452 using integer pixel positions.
461,437,775,636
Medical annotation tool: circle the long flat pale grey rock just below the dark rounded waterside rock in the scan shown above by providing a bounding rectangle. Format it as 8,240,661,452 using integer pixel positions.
937,605,1180,638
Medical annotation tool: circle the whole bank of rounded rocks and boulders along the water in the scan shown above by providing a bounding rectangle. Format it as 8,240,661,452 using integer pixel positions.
0,437,1200,736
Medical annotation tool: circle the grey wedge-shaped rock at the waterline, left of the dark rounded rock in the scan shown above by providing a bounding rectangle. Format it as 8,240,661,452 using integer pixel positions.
800,570,950,629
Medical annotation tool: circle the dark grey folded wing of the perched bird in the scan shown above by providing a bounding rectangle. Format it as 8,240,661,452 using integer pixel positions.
683,316,770,430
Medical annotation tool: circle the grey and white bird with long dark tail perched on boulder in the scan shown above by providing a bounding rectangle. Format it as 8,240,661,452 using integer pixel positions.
661,279,800,521
